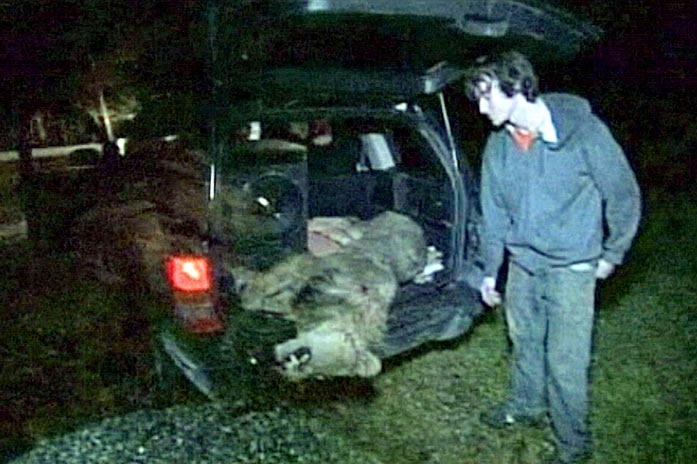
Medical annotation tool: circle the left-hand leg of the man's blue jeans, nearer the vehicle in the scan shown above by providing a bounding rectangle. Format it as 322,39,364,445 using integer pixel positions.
505,263,547,416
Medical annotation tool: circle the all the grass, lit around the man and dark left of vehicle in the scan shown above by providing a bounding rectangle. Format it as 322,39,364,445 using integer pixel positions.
0,186,697,464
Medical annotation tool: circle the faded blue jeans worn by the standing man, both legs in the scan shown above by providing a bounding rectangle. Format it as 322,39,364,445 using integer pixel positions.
506,263,596,453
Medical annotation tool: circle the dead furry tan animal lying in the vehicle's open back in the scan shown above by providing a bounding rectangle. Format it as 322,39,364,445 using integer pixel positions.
241,211,427,380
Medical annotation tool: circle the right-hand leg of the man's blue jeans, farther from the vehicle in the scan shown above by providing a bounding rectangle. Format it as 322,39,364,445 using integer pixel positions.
544,265,596,453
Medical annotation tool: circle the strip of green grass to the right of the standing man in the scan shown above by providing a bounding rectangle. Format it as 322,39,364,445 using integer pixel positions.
594,189,697,463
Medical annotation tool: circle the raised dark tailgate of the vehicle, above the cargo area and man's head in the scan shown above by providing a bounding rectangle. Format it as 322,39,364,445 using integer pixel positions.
214,0,600,103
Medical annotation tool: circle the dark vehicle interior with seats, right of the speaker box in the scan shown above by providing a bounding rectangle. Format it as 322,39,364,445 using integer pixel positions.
307,121,454,272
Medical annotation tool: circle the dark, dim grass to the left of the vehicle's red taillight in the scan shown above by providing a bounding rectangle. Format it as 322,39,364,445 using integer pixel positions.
0,244,170,462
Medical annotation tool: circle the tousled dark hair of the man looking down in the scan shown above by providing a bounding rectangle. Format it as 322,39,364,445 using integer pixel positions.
465,51,540,102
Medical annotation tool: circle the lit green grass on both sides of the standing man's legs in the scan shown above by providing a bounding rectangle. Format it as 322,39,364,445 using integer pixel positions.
298,188,697,464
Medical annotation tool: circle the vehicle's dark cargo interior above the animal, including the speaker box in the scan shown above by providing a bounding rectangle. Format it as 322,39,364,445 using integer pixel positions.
214,116,454,284
